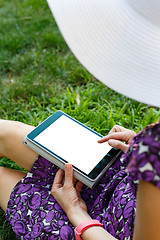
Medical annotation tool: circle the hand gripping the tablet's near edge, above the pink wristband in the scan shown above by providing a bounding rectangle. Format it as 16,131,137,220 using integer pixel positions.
51,163,87,218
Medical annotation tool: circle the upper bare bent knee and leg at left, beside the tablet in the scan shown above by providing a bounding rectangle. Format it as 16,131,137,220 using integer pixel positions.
0,120,38,170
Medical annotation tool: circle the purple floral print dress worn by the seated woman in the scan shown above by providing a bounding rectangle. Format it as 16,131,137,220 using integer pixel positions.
6,122,160,240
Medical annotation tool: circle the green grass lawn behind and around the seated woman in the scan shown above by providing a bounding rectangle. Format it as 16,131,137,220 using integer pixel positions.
0,0,160,240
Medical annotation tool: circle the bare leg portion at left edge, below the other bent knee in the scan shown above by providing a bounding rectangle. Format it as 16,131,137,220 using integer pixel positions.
0,167,26,212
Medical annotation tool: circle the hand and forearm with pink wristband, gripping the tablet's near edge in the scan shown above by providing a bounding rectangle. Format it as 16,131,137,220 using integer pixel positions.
51,163,115,240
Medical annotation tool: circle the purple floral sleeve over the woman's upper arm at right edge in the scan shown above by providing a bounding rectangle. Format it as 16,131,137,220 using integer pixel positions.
128,123,160,188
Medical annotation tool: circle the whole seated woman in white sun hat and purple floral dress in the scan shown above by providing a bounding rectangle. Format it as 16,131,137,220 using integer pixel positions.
0,0,160,240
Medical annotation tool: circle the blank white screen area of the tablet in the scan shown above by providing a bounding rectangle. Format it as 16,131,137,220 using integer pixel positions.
34,115,111,174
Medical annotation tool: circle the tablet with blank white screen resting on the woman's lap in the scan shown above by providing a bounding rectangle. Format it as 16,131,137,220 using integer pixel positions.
24,111,120,187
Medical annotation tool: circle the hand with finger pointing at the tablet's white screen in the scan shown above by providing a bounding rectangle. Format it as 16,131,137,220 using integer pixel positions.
98,125,136,152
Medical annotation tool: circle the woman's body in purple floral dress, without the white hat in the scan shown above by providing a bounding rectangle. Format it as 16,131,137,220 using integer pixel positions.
0,120,160,240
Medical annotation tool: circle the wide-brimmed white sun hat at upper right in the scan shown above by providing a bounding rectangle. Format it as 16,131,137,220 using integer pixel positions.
47,0,160,107
